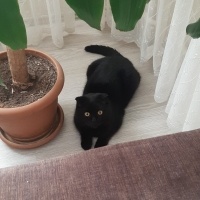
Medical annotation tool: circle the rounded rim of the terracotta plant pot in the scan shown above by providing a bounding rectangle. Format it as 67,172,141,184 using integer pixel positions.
0,48,64,115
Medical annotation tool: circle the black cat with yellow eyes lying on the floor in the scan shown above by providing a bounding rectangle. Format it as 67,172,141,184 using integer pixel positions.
74,45,140,150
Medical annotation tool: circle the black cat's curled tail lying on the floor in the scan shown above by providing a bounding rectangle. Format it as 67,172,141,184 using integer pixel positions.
85,45,121,56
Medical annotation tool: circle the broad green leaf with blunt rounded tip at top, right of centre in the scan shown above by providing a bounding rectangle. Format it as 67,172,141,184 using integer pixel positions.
110,0,149,31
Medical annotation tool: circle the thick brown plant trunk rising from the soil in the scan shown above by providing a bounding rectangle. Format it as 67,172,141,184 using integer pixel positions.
7,47,30,89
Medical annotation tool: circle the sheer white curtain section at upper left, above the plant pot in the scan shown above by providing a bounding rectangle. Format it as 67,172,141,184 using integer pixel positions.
18,0,75,48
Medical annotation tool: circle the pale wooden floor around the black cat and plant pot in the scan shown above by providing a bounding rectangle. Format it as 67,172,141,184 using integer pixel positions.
0,21,172,168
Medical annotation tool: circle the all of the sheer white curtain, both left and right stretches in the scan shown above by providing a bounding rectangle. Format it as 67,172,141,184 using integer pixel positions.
5,0,200,131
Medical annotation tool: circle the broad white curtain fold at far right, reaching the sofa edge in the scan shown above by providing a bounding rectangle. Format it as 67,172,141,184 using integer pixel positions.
166,39,200,131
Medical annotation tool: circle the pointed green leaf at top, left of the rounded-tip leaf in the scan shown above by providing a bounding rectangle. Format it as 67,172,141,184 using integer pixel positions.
65,0,104,30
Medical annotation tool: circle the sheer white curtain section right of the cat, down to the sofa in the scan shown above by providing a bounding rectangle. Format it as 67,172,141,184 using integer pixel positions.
103,0,200,131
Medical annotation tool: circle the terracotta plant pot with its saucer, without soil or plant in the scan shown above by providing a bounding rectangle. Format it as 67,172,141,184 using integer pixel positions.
0,49,64,148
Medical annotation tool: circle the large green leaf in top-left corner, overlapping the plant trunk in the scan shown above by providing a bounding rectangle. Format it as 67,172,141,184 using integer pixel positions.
0,0,27,50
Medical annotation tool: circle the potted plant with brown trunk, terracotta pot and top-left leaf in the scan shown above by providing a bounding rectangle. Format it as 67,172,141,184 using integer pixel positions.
0,0,64,148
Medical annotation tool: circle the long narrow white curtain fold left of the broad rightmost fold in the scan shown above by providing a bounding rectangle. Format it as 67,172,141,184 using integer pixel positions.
155,0,193,103
